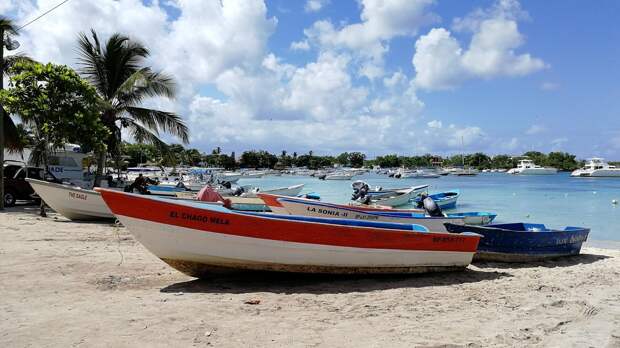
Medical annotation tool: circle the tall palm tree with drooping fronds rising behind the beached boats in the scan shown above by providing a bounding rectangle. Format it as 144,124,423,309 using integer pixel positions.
78,30,189,185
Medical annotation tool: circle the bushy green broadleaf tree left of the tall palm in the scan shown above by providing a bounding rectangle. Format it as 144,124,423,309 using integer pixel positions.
0,62,110,165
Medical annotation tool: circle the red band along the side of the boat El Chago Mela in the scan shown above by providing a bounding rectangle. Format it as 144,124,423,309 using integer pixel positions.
97,189,480,252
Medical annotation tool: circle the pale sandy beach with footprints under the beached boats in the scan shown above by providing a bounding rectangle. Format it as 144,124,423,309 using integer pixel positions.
0,206,620,347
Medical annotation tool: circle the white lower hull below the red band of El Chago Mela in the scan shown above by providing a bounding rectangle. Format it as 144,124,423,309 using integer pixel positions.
118,215,473,273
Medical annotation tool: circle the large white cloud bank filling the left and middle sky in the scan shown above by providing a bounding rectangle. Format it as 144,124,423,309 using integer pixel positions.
7,0,494,153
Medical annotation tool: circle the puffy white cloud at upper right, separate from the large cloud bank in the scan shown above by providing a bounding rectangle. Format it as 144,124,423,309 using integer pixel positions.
412,0,546,90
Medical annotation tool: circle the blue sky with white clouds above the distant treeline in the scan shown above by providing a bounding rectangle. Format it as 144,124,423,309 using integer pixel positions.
0,0,620,160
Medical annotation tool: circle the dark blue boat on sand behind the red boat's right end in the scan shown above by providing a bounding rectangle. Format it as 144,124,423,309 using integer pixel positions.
445,222,590,262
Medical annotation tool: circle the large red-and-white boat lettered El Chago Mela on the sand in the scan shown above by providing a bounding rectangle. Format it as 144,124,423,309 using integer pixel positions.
97,189,480,277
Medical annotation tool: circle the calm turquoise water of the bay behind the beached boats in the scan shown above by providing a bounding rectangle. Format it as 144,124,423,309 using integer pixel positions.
239,173,620,241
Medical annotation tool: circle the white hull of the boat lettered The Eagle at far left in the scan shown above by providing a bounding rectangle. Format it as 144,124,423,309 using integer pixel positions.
28,179,114,220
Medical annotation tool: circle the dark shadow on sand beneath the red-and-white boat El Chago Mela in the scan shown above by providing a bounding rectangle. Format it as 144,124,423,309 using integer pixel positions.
160,269,511,294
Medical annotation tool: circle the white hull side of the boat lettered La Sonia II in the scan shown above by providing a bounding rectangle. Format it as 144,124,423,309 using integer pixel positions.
279,200,465,232
